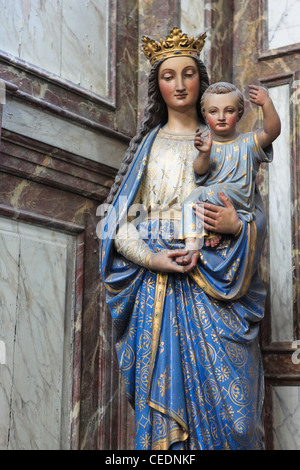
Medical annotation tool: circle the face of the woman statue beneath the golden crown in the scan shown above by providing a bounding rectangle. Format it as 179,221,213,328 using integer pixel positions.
158,56,200,112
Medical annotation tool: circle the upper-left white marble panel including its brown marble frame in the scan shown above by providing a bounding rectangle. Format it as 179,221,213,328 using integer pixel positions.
0,0,137,169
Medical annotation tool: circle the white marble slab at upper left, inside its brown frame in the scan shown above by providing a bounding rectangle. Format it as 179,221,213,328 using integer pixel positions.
0,0,109,96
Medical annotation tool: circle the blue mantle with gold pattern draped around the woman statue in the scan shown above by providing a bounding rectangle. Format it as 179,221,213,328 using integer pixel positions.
100,128,265,450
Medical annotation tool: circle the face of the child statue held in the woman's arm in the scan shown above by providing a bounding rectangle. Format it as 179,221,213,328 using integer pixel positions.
204,91,239,140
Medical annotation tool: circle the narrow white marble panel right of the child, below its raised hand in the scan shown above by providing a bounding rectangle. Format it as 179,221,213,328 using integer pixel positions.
268,84,294,342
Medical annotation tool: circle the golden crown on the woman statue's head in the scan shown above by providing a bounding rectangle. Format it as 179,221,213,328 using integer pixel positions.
142,27,206,65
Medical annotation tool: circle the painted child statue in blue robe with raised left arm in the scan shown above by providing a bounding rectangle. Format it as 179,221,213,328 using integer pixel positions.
182,82,281,253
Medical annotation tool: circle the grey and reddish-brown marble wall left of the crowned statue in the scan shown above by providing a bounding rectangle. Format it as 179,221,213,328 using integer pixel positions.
0,0,138,449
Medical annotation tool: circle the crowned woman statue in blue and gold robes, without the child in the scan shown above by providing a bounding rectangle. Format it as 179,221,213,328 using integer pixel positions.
100,28,276,450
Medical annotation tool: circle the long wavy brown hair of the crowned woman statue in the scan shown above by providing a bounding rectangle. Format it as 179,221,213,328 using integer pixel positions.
106,57,209,204
